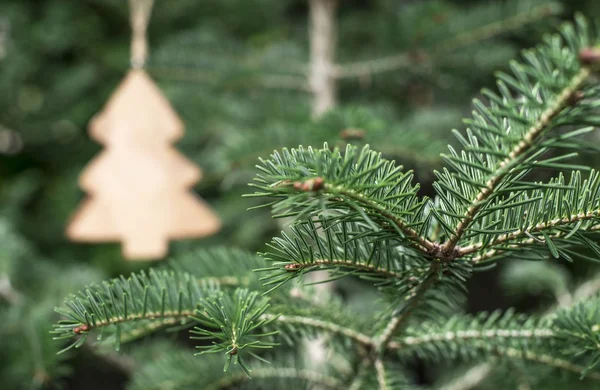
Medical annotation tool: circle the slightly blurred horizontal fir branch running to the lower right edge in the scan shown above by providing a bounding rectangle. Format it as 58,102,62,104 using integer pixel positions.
387,301,600,380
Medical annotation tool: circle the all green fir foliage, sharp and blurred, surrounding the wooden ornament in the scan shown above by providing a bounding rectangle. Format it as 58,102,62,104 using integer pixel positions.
0,0,600,389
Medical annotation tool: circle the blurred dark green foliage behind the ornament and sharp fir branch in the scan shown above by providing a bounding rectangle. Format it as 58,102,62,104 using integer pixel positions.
0,0,600,389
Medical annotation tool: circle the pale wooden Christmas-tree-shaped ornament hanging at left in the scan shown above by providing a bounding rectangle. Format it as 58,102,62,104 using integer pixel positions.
67,0,220,259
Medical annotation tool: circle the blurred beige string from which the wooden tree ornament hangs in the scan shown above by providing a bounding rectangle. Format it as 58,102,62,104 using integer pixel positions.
129,0,154,69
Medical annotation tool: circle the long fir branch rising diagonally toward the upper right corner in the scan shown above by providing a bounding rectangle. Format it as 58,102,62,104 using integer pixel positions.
434,18,599,253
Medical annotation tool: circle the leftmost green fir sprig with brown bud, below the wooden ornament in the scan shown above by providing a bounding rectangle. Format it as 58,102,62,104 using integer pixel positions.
52,270,216,350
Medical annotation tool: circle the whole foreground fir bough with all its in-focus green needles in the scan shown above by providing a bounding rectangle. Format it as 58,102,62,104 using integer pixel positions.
51,16,600,390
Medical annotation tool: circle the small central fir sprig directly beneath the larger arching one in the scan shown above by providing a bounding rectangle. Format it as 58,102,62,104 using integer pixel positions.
257,216,427,289
